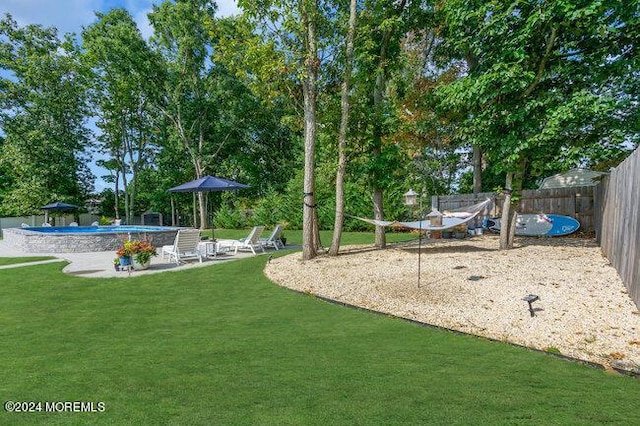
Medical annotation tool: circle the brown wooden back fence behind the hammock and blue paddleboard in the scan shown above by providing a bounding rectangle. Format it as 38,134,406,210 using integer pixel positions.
431,186,595,231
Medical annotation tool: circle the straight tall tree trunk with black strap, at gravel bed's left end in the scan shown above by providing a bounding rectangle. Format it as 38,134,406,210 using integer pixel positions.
301,0,319,260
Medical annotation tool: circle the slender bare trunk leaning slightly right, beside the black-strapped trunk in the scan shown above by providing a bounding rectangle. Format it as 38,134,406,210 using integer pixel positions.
329,0,357,256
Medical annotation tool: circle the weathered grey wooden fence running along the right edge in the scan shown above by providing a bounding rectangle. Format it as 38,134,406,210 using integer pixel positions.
595,148,640,307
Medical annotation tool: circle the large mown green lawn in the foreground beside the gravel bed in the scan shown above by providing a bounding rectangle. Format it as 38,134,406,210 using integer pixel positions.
0,233,640,425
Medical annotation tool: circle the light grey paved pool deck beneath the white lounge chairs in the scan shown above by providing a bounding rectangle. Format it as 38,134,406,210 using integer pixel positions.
0,240,282,278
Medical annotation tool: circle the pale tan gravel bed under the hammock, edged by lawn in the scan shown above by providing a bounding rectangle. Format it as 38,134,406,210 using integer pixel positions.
265,235,640,373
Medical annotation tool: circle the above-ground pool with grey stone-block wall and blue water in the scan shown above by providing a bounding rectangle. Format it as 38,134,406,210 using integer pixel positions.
2,225,179,253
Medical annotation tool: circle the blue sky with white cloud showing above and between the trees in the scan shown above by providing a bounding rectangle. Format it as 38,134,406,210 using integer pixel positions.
0,0,239,192
